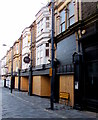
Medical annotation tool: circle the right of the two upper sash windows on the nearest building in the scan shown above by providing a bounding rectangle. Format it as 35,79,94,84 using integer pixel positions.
67,0,75,28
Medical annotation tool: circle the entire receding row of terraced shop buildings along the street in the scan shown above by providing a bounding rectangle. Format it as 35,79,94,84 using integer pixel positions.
1,0,98,111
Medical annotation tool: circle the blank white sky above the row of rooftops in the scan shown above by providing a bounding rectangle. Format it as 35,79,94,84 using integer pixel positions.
0,0,47,60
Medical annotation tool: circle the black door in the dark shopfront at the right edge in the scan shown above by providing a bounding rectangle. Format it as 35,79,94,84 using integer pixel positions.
85,45,98,109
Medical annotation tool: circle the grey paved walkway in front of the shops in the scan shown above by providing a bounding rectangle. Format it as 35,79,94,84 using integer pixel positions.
0,79,96,120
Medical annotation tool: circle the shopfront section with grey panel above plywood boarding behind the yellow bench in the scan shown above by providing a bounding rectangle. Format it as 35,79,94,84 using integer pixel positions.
56,31,76,107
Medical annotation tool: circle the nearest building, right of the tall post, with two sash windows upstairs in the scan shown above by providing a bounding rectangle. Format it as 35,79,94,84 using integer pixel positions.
54,0,98,110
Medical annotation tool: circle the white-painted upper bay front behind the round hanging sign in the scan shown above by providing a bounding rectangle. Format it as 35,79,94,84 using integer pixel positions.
22,28,31,69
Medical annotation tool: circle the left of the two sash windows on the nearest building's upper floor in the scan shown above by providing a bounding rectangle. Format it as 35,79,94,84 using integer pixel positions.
60,10,65,32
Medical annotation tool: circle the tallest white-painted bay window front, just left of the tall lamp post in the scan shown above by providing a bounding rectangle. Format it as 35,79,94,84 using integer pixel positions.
36,6,51,66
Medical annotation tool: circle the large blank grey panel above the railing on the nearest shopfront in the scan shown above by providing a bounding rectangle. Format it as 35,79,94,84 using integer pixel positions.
57,34,76,65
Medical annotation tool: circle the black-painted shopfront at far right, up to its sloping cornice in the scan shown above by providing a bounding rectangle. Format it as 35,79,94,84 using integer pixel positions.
75,15,98,112
